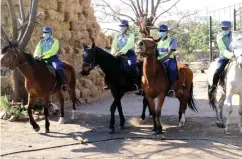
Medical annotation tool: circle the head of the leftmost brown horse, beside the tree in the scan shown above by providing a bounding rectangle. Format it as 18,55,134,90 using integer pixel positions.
0,43,23,70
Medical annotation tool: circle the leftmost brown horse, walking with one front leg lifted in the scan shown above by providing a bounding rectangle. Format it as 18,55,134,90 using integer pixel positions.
0,45,80,133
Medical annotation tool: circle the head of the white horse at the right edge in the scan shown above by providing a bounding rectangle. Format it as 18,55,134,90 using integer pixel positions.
232,35,242,68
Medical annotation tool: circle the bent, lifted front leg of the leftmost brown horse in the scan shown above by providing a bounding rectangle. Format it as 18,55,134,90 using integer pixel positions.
28,94,40,132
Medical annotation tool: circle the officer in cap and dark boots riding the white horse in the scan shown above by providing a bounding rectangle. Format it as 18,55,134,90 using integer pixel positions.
209,21,233,93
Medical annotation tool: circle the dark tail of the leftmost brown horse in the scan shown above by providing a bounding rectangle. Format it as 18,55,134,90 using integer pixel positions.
68,65,81,106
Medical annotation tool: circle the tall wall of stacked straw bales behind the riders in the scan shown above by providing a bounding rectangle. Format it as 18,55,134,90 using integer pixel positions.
1,0,111,98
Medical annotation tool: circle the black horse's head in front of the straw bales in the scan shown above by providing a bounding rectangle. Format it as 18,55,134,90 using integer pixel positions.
81,42,97,76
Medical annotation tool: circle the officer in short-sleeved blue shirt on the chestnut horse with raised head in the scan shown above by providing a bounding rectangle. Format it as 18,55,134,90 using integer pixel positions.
157,24,178,96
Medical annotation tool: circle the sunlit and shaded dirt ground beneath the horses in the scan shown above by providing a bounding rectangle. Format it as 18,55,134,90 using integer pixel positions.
1,69,242,159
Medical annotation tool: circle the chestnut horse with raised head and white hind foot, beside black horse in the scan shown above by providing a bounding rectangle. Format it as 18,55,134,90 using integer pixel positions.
136,38,197,134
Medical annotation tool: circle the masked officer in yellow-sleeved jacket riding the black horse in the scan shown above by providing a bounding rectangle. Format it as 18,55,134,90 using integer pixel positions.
104,20,137,90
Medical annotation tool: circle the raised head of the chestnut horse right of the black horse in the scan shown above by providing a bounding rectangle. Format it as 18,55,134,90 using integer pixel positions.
135,38,156,58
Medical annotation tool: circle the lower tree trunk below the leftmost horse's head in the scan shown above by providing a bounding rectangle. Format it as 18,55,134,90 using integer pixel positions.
11,69,28,104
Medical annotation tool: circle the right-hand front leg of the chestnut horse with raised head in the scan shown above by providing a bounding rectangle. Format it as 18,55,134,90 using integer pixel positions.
156,94,165,134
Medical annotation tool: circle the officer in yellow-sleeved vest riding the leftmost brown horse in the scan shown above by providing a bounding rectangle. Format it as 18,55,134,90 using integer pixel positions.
34,27,69,91
